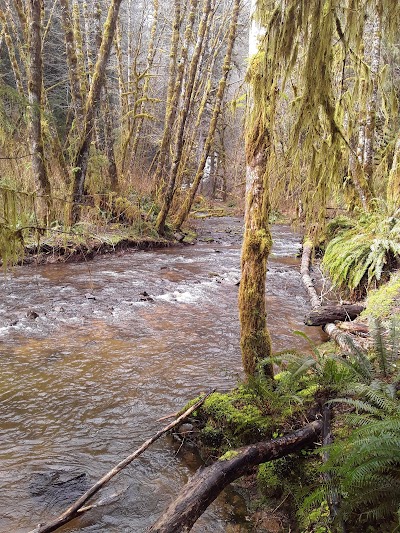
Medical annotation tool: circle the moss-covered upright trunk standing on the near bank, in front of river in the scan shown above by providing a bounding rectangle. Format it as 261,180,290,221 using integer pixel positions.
239,0,273,376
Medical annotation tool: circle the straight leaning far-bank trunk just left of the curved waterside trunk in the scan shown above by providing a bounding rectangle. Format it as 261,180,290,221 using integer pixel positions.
156,0,211,235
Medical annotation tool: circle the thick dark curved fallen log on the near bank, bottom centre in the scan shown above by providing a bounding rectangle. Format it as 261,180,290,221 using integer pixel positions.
148,420,322,533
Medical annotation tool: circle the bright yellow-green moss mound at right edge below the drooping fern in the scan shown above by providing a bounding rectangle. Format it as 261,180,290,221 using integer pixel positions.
361,272,400,319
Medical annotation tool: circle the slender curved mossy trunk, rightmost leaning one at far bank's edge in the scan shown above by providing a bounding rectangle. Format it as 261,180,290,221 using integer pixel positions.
175,0,240,228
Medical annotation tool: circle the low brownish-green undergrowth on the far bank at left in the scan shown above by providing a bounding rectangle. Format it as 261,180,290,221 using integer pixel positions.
0,190,174,267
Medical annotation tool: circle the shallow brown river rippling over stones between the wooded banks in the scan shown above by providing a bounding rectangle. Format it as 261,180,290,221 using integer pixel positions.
0,218,320,533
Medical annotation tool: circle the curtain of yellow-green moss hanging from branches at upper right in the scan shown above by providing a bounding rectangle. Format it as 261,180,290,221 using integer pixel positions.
247,0,400,233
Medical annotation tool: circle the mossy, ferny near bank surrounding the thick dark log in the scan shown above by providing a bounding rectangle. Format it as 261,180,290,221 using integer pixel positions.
186,320,400,533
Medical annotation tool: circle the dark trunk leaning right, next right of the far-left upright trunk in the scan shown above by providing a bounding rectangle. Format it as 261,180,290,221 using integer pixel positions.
71,0,122,224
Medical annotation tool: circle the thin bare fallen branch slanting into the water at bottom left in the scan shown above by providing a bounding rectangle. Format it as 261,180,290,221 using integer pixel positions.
29,390,214,533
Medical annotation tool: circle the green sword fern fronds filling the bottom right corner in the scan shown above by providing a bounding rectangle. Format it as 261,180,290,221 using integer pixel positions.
303,320,400,531
